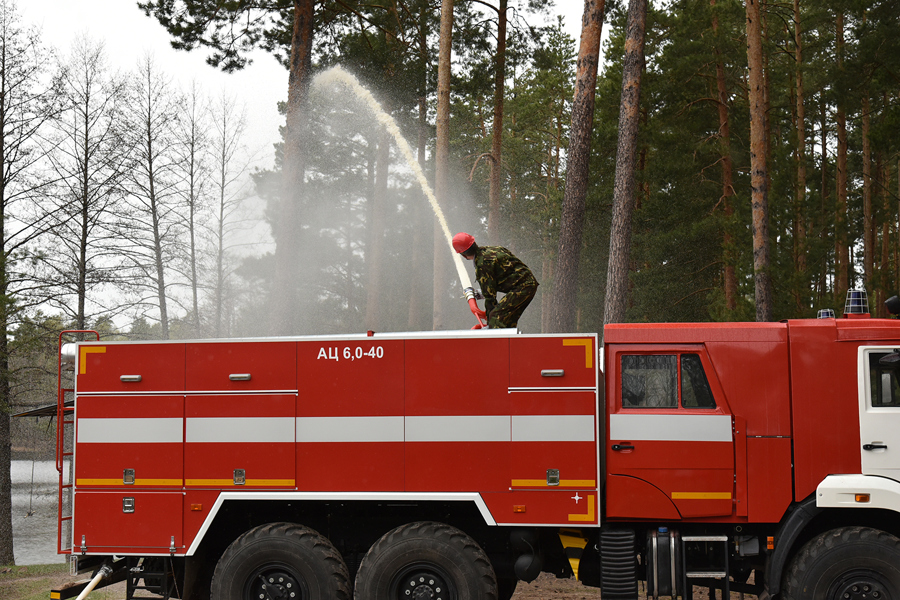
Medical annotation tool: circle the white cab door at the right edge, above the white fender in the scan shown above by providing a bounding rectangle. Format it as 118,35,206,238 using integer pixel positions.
859,346,900,481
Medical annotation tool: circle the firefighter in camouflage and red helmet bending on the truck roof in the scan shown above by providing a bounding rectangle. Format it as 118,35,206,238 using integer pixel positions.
453,232,538,329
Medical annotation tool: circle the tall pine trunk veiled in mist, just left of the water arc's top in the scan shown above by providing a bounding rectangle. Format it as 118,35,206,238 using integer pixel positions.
272,0,315,335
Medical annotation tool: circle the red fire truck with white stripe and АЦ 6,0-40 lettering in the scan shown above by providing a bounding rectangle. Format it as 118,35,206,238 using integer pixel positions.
47,298,900,600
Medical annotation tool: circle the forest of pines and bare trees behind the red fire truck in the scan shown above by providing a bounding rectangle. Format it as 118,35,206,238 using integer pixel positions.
0,0,900,564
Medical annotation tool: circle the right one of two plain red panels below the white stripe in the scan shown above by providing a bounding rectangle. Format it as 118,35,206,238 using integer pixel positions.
406,442,510,492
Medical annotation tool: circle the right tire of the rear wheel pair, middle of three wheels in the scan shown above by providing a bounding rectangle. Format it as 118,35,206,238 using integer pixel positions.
353,521,497,600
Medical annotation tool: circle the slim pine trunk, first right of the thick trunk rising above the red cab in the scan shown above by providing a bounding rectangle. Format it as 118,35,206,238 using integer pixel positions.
794,0,809,311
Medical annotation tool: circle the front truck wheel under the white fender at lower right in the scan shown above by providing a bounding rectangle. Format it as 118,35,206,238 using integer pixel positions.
782,527,900,600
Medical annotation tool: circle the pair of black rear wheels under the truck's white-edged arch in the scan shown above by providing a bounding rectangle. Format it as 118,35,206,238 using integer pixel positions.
212,522,500,600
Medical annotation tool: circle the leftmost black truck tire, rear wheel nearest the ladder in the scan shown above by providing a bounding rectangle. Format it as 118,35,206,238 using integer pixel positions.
211,523,351,600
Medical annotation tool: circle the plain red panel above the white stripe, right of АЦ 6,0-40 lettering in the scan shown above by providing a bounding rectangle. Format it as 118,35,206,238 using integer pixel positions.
404,337,510,415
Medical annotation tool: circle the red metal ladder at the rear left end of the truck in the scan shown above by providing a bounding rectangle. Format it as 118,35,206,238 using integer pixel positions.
56,329,100,554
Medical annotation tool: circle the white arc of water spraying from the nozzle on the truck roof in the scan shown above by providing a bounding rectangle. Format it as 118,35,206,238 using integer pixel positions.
313,67,487,329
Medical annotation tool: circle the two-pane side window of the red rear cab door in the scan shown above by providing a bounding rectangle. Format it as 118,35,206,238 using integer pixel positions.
621,353,716,409
